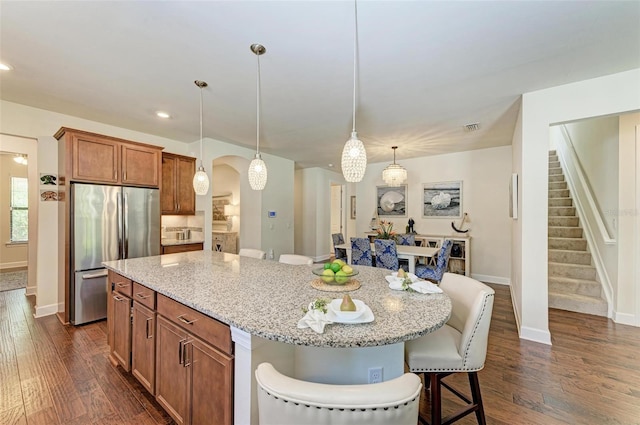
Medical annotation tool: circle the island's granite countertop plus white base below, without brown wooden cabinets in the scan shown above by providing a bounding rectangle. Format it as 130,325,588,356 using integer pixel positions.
105,251,451,424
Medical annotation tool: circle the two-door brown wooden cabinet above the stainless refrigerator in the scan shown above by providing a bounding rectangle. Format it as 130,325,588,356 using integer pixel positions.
55,127,163,187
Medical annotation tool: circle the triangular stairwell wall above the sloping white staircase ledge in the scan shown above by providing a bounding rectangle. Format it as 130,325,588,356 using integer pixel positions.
564,116,619,235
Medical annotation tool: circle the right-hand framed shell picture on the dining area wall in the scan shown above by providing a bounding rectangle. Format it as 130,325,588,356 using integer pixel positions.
422,181,462,218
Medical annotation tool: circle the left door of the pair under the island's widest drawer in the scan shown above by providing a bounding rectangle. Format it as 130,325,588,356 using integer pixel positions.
156,316,190,424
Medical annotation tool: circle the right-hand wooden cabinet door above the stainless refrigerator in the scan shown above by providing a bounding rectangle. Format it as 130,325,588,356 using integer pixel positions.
122,144,161,187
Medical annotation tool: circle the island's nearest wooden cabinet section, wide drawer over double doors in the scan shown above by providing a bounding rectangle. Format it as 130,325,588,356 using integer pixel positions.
156,295,233,425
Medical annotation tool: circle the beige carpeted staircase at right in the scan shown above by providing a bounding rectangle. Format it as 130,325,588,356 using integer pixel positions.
549,151,607,316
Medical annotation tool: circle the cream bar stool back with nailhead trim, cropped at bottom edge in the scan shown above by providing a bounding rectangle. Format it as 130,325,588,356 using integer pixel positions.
256,363,422,425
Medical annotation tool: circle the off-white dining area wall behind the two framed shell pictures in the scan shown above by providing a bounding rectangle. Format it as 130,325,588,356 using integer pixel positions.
356,146,512,284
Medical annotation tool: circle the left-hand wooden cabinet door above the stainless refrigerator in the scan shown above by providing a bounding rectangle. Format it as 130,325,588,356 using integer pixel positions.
71,134,120,183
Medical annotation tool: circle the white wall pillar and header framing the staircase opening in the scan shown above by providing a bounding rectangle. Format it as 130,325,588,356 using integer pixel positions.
513,69,640,344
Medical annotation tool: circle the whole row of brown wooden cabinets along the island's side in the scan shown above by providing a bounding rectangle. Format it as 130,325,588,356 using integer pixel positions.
107,271,234,425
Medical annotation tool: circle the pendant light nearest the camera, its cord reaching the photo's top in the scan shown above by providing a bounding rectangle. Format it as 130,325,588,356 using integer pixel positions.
342,1,367,183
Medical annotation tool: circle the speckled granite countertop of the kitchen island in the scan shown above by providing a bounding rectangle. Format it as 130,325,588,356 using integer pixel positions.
104,251,451,348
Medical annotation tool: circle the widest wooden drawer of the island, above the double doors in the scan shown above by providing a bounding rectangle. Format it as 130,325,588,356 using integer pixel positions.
157,294,232,354
